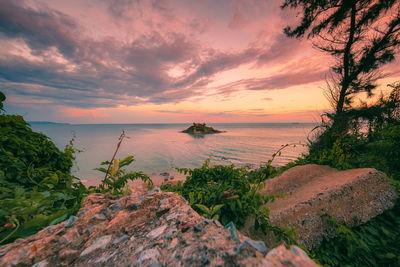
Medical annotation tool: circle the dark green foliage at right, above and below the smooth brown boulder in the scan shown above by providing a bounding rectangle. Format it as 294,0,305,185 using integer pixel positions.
302,83,400,266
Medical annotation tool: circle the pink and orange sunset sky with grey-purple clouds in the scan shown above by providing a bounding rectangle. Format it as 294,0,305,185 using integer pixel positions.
0,0,400,123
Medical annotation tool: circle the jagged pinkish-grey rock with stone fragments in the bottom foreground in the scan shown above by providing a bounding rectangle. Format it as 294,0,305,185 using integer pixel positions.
0,189,317,267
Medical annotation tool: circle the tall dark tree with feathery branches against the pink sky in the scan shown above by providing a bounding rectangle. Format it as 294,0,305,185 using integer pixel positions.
282,0,400,119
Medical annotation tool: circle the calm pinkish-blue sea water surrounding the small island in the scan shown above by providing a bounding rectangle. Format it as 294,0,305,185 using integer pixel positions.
31,123,314,184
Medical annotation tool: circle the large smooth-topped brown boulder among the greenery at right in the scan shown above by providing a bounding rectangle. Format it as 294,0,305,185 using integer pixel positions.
242,164,397,249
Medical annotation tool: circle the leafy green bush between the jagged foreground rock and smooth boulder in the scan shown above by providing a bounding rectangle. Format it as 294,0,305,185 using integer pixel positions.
161,159,296,247
